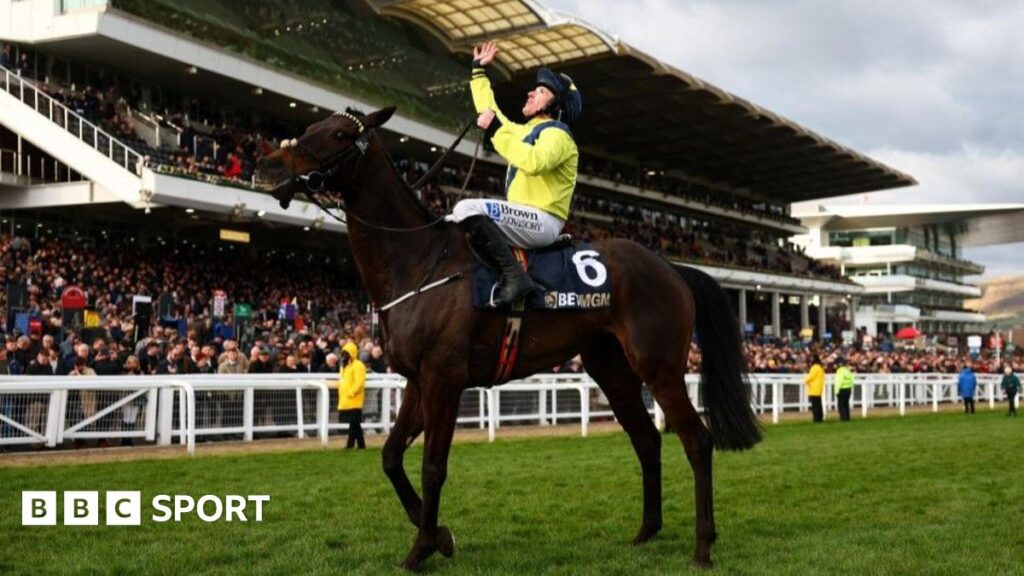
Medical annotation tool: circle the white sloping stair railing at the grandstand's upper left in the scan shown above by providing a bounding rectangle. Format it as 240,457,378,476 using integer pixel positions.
0,67,142,175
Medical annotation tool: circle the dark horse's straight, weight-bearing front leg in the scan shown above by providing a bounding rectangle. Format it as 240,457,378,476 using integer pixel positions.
402,375,462,570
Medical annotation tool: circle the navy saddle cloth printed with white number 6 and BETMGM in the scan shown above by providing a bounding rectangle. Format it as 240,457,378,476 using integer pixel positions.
472,244,611,310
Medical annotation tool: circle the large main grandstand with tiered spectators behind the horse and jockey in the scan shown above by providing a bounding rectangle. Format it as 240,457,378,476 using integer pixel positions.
0,0,914,337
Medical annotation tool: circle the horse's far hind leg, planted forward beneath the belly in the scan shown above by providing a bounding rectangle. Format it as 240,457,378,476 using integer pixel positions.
583,337,662,544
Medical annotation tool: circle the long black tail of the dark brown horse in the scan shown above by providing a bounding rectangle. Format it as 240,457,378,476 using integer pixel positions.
676,266,761,450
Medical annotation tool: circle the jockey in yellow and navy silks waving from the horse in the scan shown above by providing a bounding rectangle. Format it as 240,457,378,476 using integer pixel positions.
446,42,583,307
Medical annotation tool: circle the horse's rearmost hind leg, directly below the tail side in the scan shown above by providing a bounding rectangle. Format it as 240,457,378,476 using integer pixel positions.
647,367,717,568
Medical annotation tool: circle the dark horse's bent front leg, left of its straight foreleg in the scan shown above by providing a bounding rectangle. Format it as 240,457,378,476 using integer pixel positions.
381,382,423,526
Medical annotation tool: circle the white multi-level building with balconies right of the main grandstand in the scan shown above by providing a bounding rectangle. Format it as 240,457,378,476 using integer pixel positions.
794,203,1024,334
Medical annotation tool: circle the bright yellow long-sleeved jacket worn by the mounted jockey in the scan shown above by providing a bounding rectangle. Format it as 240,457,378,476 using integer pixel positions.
469,68,580,220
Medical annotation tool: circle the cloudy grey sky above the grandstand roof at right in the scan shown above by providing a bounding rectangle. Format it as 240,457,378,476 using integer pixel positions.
541,0,1024,277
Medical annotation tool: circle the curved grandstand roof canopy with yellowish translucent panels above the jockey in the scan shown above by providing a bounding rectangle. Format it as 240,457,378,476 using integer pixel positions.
368,0,916,202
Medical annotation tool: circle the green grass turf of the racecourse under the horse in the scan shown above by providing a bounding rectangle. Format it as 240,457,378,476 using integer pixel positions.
0,410,1024,575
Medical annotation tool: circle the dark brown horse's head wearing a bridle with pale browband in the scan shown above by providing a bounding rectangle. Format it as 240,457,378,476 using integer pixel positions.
256,107,394,208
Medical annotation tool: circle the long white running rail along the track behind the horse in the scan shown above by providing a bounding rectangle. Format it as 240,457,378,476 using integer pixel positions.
0,374,1004,454
